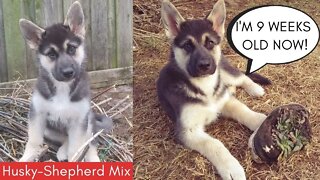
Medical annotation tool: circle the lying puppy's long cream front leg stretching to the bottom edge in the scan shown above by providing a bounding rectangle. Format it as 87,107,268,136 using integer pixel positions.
176,104,245,180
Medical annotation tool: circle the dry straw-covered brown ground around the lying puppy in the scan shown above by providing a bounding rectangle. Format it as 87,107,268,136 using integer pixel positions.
133,0,320,180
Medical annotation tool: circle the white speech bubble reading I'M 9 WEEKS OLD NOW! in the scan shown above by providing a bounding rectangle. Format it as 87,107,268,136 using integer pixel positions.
227,5,319,74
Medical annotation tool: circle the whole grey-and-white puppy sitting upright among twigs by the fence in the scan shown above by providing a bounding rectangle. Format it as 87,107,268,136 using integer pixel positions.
20,2,112,161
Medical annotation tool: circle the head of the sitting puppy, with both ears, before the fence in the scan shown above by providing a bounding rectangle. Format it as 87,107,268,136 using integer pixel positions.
19,2,85,81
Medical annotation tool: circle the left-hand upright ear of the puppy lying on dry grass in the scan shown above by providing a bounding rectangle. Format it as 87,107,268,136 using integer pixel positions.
161,0,185,40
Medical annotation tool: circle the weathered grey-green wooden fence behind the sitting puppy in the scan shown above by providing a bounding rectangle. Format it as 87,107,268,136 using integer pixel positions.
0,0,133,83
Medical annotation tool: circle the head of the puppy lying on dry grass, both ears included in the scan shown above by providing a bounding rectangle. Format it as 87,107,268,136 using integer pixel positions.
161,0,226,77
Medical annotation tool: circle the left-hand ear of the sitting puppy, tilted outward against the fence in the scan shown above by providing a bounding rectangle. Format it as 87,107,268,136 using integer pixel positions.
19,19,44,49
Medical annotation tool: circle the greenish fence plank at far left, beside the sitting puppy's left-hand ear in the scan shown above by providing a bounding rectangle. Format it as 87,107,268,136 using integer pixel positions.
2,0,26,80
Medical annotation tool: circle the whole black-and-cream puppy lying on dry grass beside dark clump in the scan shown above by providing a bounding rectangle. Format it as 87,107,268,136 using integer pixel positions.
157,0,270,180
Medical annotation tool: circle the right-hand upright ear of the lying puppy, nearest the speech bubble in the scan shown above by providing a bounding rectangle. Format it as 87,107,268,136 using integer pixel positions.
207,0,226,37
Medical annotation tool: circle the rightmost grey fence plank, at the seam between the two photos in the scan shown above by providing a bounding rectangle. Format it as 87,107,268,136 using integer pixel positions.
116,0,133,67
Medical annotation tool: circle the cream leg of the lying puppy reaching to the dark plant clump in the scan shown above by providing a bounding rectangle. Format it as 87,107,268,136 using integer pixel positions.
222,97,267,131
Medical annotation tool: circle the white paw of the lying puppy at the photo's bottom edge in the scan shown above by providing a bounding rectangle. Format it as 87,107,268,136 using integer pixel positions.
217,157,246,180
